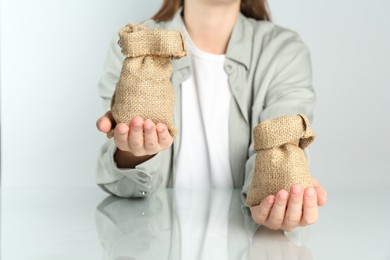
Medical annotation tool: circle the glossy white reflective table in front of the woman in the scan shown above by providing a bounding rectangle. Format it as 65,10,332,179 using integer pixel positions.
1,187,390,260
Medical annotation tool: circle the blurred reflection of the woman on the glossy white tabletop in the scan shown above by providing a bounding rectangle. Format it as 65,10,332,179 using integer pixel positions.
96,189,312,260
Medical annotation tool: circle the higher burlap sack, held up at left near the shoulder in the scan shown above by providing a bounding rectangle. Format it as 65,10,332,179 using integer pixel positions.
108,24,186,137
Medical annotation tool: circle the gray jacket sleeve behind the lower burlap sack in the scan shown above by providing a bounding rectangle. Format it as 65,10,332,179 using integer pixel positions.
242,35,316,197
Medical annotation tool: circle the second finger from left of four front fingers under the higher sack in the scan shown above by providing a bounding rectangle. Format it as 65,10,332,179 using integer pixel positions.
128,116,145,156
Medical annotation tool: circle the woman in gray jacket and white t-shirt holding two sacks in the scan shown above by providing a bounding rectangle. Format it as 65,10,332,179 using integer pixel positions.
97,0,326,230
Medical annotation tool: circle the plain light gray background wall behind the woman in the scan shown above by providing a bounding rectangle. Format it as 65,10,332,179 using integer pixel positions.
0,0,390,190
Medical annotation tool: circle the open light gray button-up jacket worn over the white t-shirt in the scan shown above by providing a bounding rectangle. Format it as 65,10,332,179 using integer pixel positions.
96,11,315,197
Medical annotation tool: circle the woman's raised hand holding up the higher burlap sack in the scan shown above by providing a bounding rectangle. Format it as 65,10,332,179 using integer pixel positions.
96,111,173,168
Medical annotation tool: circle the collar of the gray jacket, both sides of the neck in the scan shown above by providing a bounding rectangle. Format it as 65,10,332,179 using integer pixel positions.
162,7,253,70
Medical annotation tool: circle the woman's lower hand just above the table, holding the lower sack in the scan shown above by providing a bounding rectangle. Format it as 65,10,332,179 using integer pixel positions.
250,179,327,231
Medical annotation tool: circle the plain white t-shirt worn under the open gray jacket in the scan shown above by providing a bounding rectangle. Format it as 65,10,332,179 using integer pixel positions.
175,33,233,189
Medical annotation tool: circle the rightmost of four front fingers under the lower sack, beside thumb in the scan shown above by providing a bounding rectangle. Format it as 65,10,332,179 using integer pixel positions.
300,187,318,226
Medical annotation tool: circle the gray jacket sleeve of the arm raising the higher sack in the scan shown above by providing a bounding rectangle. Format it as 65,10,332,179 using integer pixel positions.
96,36,162,198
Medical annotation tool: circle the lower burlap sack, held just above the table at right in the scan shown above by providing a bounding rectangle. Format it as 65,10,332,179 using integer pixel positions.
246,115,315,207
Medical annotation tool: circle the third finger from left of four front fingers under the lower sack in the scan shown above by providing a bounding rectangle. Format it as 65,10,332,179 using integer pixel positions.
283,184,303,231
